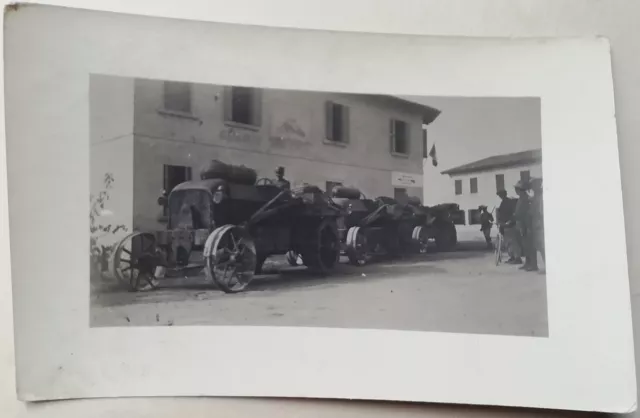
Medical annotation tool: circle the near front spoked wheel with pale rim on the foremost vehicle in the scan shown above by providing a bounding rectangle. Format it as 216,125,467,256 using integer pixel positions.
204,225,257,293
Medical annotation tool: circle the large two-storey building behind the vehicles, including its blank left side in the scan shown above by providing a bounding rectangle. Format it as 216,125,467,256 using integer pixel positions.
91,76,439,238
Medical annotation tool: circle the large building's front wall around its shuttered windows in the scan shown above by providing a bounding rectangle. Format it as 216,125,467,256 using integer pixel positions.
134,80,430,229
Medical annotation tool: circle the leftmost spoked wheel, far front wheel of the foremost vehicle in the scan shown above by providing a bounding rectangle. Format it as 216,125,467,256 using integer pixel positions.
111,232,159,292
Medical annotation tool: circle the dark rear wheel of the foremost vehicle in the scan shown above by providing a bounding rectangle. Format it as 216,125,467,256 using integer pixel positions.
301,220,340,275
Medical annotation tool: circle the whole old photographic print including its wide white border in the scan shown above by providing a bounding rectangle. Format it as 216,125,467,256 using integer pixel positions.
3,5,636,412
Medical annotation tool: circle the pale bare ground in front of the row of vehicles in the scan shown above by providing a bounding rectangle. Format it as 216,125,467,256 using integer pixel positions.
91,237,548,336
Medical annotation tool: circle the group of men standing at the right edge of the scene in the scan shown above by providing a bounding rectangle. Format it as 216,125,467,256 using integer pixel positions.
496,178,545,271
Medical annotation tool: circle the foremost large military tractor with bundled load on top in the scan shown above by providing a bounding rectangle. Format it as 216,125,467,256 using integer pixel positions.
112,161,348,293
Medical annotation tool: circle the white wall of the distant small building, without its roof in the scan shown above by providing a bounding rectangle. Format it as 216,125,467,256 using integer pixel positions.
445,164,542,224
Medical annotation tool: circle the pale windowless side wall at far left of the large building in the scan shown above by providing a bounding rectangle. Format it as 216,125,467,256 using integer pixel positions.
89,75,134,245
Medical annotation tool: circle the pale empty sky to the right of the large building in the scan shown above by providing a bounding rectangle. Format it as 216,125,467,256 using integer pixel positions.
407,97,542,205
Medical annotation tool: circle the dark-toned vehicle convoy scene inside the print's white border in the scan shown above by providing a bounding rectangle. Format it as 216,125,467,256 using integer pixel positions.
90,75,548,337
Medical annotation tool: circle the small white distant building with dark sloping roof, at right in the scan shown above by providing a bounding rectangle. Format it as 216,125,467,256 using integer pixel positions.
442,149,542,225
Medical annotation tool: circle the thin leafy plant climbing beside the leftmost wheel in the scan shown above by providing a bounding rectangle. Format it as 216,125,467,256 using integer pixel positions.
89,173,128,273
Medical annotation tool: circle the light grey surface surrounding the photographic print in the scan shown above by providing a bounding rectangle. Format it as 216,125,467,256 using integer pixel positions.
0,0,640,417
